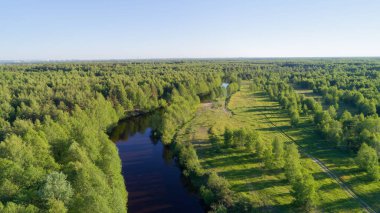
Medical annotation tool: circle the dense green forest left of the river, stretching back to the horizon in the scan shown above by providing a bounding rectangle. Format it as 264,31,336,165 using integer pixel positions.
0,63,222,212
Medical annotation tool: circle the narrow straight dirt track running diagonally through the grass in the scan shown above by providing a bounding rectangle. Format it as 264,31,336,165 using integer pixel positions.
264,107,376,213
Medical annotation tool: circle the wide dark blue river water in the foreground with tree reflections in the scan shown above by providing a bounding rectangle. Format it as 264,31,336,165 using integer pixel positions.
111,113,204,213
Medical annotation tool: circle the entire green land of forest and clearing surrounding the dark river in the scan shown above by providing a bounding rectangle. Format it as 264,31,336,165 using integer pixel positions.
0,58,380,212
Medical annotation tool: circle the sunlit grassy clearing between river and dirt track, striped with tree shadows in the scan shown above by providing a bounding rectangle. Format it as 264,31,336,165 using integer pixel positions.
177,84,362,212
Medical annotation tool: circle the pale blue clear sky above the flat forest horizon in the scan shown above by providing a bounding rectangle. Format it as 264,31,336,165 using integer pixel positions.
0,0,380,60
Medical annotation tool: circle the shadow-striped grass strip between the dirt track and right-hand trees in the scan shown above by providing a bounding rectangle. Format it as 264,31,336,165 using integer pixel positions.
290,85,380,212
